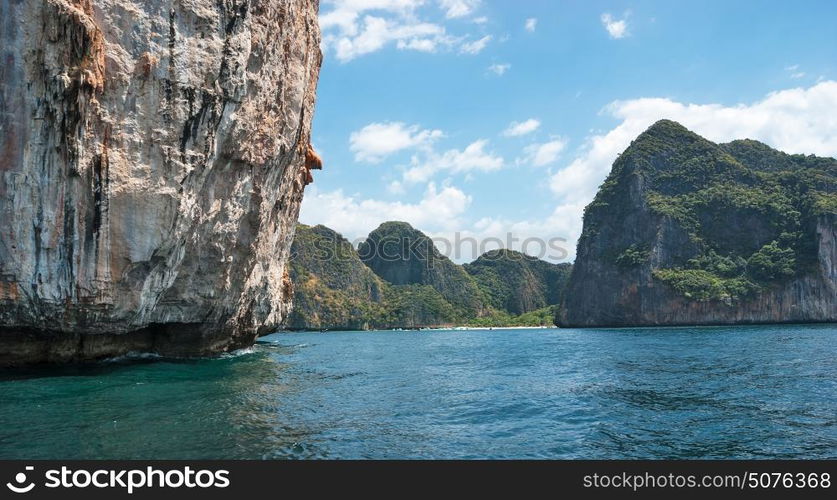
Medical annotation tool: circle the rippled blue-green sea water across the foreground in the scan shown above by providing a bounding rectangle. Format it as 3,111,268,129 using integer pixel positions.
0,325,837,459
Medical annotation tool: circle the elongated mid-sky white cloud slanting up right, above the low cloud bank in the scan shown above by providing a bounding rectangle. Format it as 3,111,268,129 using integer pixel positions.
404,139,504,183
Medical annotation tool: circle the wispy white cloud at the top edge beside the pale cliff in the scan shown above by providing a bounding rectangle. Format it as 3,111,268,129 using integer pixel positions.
319,0,488,62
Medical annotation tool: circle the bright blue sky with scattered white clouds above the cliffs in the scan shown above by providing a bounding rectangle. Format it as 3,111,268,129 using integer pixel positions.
301,0,837,262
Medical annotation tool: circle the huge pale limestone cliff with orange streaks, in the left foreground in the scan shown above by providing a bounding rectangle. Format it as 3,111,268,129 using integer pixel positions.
0,0,321,364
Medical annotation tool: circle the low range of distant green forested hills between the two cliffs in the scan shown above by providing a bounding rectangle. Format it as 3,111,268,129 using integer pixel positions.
285,222,571,330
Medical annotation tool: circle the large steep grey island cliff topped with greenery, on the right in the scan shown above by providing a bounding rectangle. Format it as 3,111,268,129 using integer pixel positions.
558,121,837,326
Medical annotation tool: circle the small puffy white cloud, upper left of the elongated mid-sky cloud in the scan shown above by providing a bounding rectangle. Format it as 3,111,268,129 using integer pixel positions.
349,122,444,163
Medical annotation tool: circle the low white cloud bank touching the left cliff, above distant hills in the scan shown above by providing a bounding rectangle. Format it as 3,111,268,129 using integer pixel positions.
300,183,471,241
